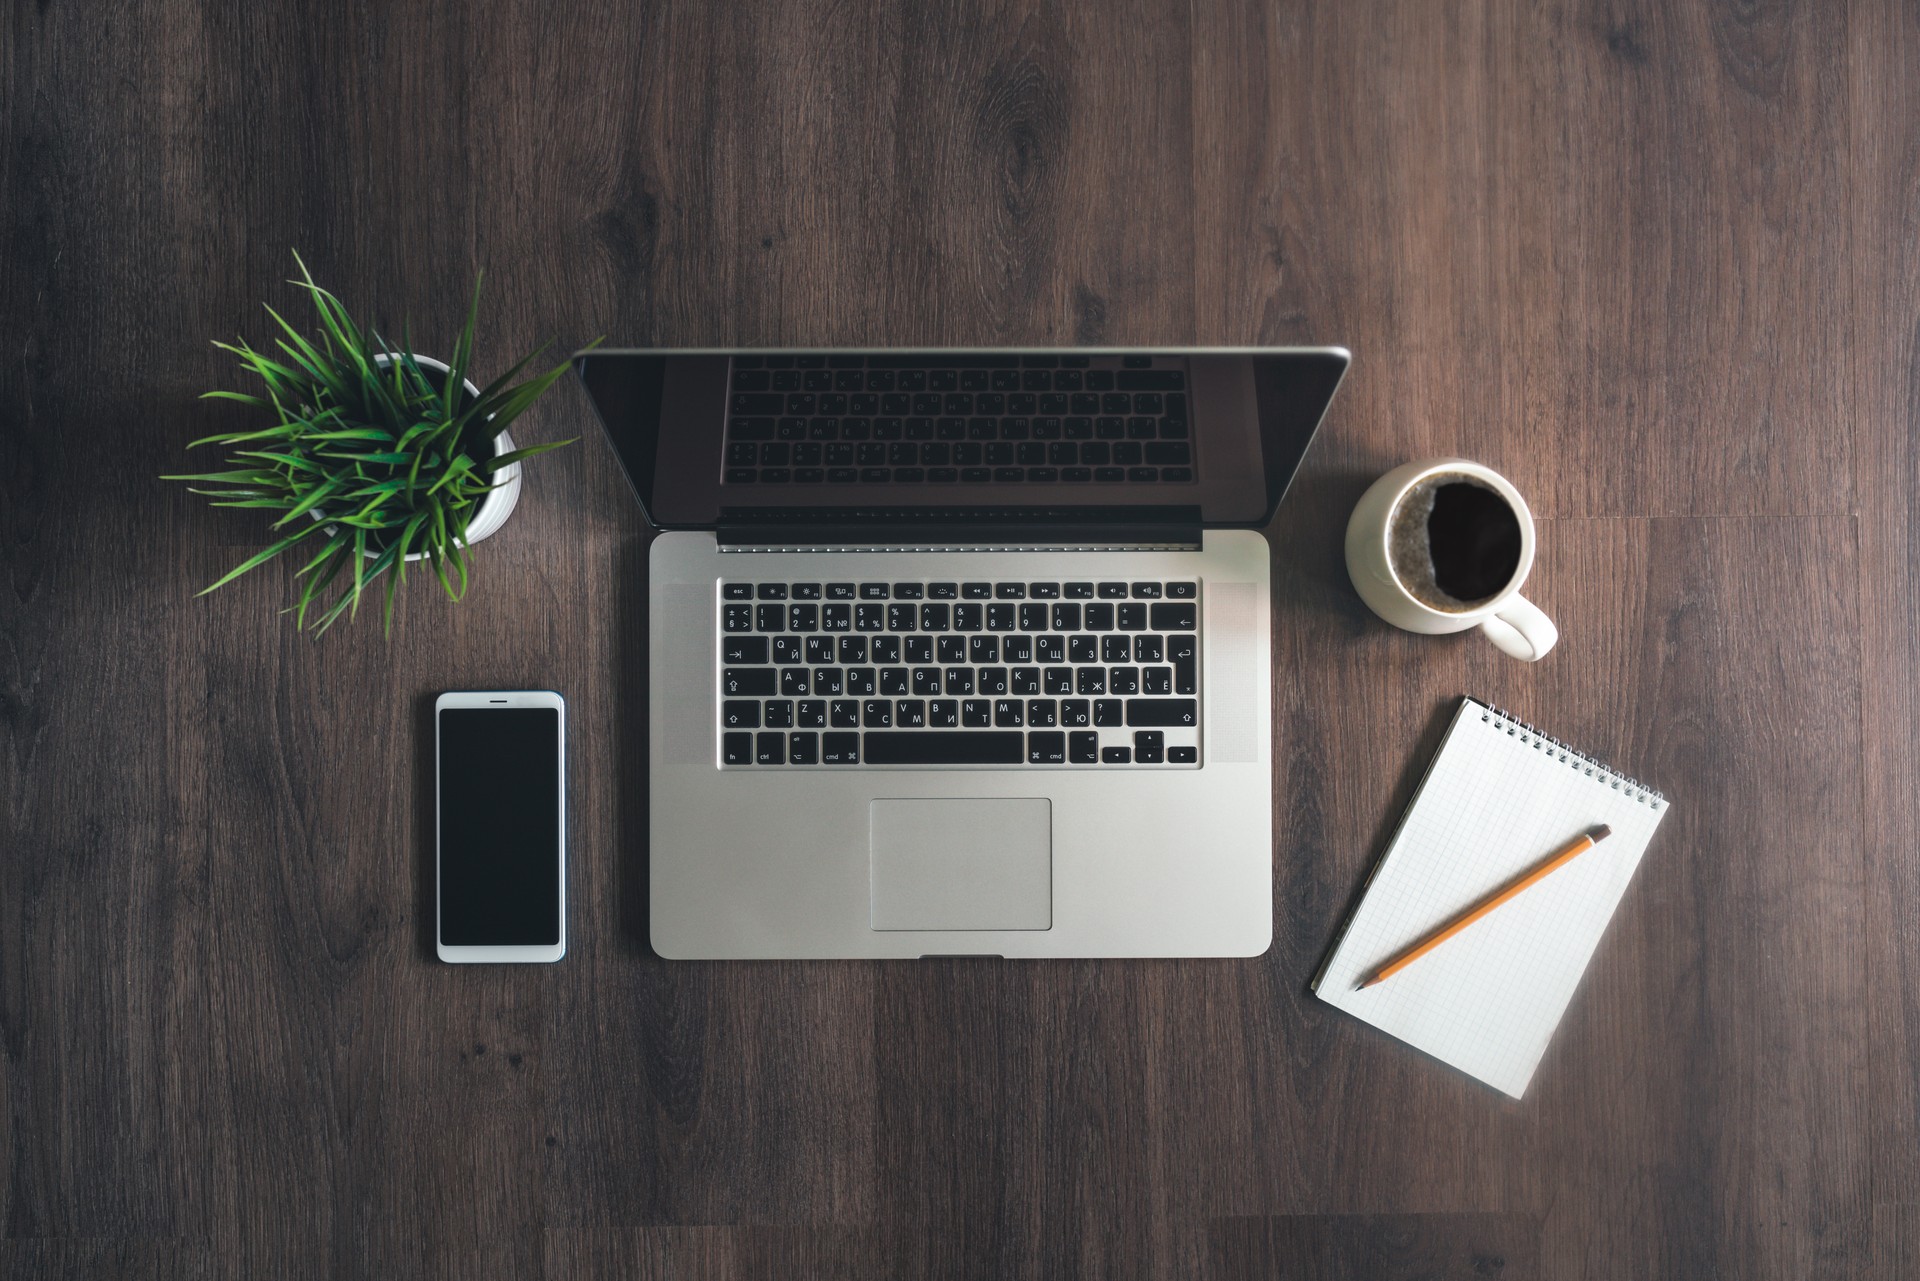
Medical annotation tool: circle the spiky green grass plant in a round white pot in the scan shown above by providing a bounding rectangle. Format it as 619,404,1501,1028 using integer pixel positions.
163,254,591,634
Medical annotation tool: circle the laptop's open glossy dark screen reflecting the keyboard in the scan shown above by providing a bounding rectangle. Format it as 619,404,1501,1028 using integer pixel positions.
576,348,1348,528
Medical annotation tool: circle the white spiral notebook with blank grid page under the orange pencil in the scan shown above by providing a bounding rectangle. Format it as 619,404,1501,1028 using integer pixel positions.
1313,699,1667,1099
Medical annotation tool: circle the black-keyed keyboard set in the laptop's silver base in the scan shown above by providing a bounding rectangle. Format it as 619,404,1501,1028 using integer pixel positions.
718,580,1200,768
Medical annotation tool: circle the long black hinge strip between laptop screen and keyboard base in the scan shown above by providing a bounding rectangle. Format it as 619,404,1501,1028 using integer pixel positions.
716,507,1200,551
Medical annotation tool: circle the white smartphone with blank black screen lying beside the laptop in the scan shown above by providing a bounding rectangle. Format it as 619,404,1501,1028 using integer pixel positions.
434,689,566,962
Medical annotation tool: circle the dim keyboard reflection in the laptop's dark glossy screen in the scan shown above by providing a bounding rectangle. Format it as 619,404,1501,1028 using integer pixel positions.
722,351,1198,486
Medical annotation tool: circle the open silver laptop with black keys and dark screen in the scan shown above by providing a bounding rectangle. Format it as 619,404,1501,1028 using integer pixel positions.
576,348,1350,958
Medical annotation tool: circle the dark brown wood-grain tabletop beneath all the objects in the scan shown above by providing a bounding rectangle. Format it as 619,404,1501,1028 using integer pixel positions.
0,0,1920,1279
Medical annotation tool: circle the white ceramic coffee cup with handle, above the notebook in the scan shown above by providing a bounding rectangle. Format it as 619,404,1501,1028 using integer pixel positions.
1346,459,1559,663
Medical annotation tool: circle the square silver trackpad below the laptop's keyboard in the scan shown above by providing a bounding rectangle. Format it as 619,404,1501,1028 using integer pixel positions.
868,799,1054,930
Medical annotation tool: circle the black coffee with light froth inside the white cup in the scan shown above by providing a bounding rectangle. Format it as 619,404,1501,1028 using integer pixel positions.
1388,472,1521,613
